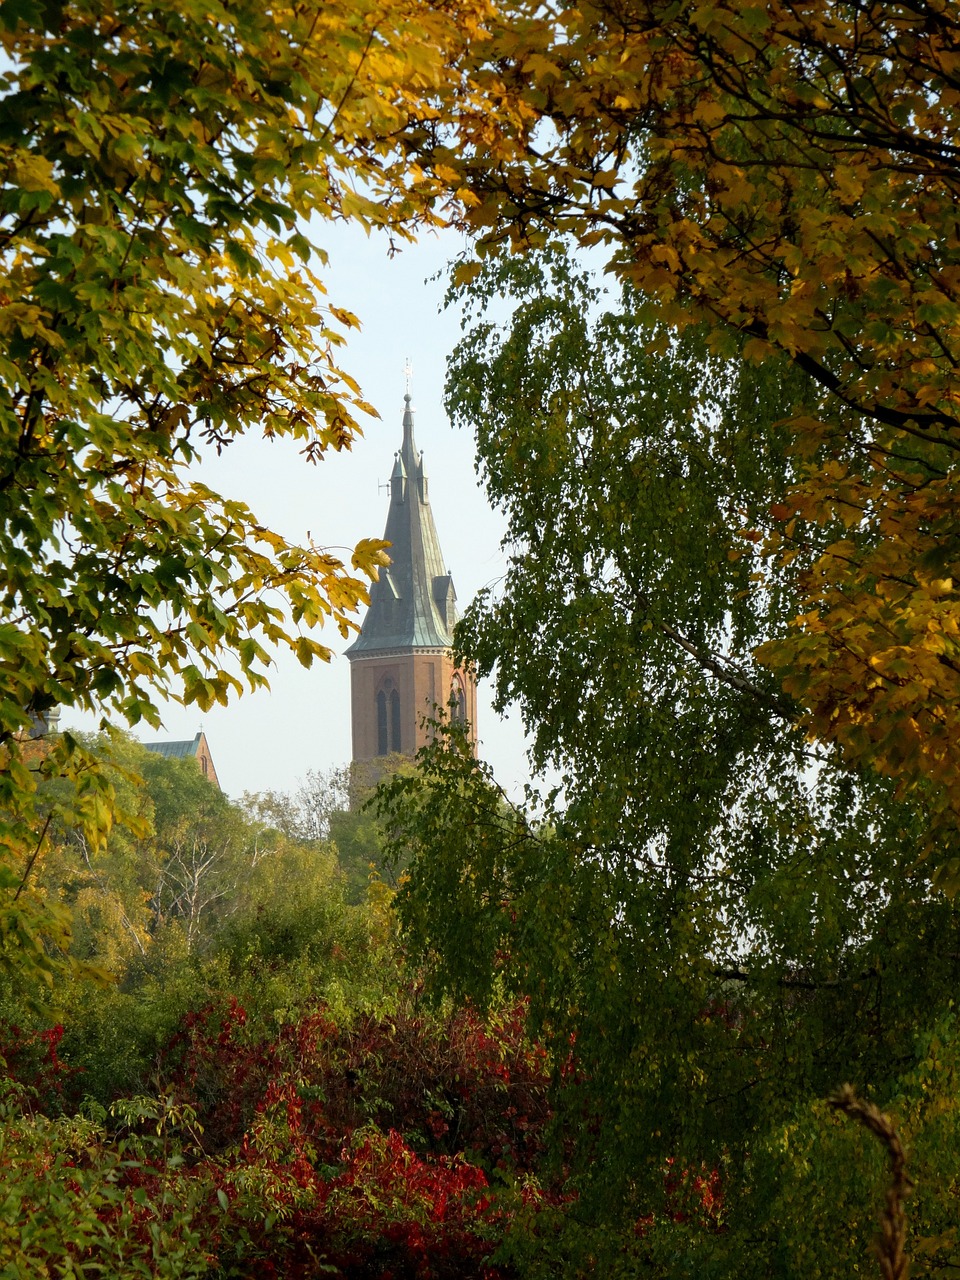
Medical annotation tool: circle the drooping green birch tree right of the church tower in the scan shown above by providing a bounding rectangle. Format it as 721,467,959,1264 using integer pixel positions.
384,251,960,1280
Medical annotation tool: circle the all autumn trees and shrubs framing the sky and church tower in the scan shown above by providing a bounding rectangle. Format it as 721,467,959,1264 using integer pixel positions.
0,0,960,1276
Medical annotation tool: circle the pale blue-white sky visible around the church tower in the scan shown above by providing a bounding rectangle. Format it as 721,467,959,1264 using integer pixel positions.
63,220,527,797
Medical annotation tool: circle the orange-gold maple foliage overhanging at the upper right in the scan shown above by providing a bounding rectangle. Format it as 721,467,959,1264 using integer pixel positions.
431,0,960,892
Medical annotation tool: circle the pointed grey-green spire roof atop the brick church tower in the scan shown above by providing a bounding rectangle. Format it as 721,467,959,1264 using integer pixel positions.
347,394,457,659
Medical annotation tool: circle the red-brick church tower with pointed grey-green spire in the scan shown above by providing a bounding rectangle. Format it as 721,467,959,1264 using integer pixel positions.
347,393,476,763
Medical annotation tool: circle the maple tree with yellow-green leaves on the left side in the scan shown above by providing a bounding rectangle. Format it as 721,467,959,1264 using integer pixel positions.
0,0,506,978
